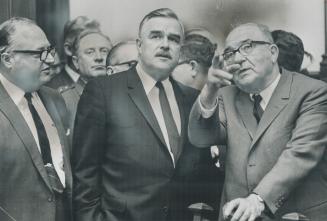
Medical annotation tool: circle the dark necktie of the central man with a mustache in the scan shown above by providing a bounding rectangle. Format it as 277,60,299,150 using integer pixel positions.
156,81,179,162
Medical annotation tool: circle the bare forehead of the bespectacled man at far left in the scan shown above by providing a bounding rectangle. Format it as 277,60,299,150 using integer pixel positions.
10,25,50,50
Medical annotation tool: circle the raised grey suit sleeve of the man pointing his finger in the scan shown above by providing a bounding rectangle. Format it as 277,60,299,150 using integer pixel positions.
188,93,226,148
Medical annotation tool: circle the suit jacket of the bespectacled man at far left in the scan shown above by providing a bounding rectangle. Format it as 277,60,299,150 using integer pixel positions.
0,84,72,221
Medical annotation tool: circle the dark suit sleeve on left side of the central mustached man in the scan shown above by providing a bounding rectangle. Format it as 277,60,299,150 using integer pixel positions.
72,80,106,221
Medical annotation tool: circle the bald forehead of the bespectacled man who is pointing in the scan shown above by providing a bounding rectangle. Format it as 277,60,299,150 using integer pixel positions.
225,24,270,48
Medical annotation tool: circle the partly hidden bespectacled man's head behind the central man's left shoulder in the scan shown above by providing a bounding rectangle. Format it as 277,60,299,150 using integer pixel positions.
106,41,137,75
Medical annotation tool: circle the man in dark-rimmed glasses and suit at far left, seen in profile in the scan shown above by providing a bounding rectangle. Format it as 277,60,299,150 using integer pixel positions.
0,18,72,221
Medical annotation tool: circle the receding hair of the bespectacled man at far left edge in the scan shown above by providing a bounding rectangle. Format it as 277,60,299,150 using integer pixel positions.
0,17,36,53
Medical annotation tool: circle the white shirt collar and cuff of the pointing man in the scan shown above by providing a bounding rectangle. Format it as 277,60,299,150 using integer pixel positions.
199,74,280,118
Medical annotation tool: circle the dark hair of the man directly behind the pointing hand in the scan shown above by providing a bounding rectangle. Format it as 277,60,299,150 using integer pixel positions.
180,33,217,68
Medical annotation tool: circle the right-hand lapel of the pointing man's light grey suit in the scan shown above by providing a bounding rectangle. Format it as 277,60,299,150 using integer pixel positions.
251,71,293,148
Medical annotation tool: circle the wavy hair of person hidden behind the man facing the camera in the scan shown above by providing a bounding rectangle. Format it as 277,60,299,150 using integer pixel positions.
64,16,100,44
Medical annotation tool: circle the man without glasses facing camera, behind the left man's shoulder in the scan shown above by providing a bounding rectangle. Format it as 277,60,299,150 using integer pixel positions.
59,30,112,136
